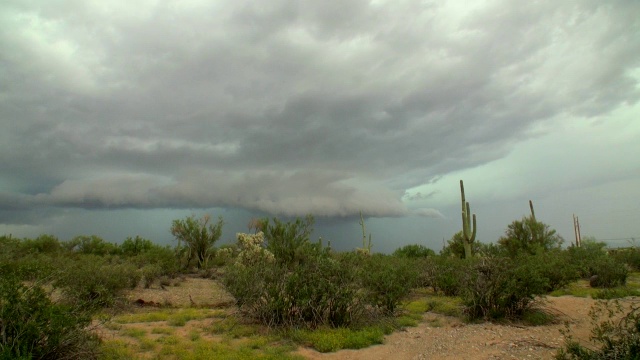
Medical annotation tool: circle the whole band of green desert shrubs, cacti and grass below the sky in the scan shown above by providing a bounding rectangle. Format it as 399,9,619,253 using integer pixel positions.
0,190,640,359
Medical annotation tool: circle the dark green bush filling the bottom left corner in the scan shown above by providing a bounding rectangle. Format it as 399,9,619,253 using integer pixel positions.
0,276,98,359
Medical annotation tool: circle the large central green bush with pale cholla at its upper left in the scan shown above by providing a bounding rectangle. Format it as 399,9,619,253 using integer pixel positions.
223,233,364,328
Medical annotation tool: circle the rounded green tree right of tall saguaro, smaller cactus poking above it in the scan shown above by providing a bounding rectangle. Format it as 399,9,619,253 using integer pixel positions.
498,216,564,256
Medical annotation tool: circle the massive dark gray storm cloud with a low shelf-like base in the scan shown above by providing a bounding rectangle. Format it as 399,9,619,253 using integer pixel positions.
0,0,640,223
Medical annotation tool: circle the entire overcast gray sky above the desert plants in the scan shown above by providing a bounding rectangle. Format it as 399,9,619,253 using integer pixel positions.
0,0,640,252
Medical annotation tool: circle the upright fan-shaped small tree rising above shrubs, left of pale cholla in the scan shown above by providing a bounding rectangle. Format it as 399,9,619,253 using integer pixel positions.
171,215,224,269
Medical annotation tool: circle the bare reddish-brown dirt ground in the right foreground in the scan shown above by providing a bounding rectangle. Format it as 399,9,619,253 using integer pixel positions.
298,296,594,360
